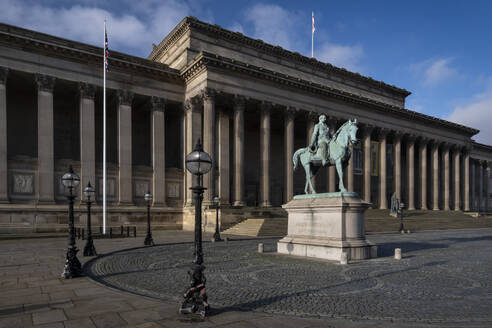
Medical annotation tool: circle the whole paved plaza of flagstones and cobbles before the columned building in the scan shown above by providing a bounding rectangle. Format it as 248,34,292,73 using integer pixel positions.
0,229,492,328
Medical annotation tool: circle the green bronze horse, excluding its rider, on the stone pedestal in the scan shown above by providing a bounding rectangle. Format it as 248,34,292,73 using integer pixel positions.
292,119,358,194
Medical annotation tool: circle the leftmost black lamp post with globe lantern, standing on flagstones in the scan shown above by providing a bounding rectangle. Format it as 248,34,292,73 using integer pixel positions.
62,165,82,279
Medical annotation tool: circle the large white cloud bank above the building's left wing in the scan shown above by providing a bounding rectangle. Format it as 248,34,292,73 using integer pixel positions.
0,0,192,56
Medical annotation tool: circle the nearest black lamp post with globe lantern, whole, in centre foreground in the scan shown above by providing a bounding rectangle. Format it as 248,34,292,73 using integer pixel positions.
179,139,212,317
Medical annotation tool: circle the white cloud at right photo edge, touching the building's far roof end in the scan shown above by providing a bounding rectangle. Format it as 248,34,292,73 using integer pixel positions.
446,78,492,145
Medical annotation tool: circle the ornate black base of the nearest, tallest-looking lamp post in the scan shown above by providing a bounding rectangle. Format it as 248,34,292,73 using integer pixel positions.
179,264,210,318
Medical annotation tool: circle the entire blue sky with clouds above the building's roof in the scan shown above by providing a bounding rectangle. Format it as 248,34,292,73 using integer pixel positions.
0,0,492,144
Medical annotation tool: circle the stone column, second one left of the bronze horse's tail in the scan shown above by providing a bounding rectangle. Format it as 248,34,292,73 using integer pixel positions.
260,101,272,207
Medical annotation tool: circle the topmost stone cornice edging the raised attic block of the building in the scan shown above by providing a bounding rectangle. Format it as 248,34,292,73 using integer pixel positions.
147,16,412,97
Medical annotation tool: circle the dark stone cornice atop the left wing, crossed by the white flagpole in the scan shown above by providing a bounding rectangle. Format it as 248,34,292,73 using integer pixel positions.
0,23,181,82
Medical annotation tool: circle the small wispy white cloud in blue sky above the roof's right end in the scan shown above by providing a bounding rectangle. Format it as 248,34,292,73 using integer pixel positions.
410,58,459,87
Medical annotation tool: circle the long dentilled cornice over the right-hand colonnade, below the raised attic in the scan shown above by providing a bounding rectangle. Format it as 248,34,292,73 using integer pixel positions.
181,51,480,137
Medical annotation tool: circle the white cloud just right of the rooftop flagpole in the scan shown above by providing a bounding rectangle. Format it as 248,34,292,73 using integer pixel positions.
315,43,364,71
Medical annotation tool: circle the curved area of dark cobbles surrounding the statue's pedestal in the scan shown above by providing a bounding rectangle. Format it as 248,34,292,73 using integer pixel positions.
87,229,492,324
